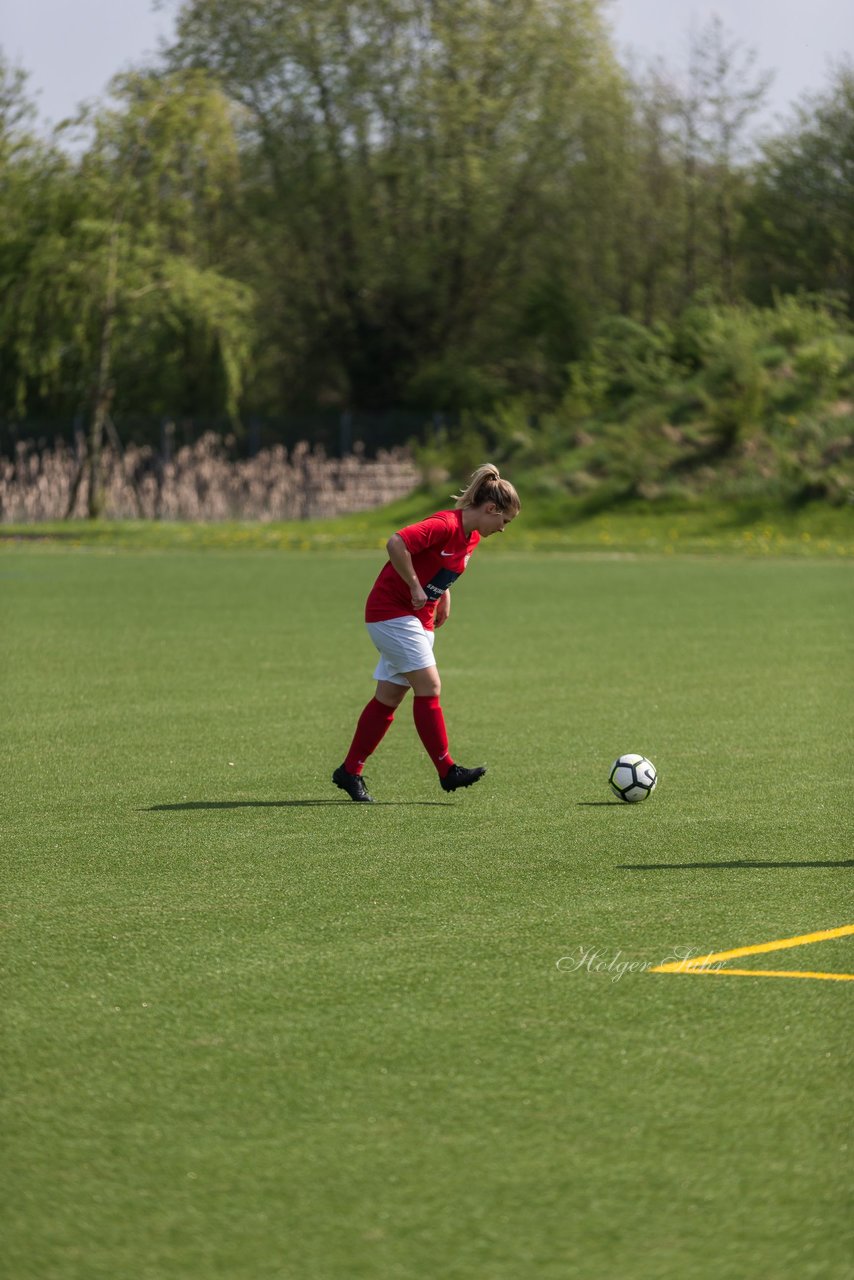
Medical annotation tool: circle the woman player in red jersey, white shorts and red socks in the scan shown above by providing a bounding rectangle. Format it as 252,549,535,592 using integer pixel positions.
332,462,521,803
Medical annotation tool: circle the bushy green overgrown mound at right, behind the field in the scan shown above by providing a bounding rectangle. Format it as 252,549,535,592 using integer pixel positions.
448,298,854,521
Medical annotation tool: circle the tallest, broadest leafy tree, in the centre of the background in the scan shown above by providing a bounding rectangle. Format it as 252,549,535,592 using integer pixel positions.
166,0,624,407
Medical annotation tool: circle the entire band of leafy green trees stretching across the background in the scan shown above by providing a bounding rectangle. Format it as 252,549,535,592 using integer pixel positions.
0,0,854,435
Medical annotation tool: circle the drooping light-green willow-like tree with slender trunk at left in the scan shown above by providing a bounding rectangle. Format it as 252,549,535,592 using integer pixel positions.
3,72,254,516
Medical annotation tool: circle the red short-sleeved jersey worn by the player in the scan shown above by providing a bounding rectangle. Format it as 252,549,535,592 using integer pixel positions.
365,511,480,631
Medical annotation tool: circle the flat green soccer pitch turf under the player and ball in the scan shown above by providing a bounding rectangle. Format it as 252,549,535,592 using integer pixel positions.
0,535,854,1280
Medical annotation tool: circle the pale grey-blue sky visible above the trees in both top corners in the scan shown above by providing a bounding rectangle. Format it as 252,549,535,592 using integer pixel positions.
0,0,854,135
